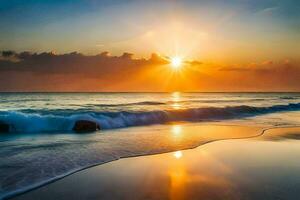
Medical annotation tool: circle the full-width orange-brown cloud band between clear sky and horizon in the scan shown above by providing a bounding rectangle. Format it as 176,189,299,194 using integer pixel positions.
0,51,300,92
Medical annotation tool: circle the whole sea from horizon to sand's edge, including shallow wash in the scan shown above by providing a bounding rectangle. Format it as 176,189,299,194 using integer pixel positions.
0,92,300,198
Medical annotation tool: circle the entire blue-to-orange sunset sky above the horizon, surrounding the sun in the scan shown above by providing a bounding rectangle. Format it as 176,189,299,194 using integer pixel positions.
0,0,300,91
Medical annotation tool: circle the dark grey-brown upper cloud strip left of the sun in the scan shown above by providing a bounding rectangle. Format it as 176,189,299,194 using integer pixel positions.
0,52,162,76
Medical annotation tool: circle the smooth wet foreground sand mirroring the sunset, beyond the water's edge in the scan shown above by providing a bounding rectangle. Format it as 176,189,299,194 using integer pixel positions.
13,127,300,200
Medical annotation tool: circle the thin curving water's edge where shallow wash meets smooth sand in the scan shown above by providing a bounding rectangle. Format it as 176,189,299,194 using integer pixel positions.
3,124,300,199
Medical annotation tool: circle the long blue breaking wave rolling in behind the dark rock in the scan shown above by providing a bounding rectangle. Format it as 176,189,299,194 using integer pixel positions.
0,103,300,132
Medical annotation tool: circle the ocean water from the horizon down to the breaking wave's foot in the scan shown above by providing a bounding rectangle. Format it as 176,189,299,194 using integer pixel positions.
0,92,300,134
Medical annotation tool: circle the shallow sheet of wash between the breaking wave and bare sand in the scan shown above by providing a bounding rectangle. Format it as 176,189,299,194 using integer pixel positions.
0,123,263,199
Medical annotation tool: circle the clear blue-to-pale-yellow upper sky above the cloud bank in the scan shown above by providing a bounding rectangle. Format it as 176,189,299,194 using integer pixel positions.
0,0,300,59
